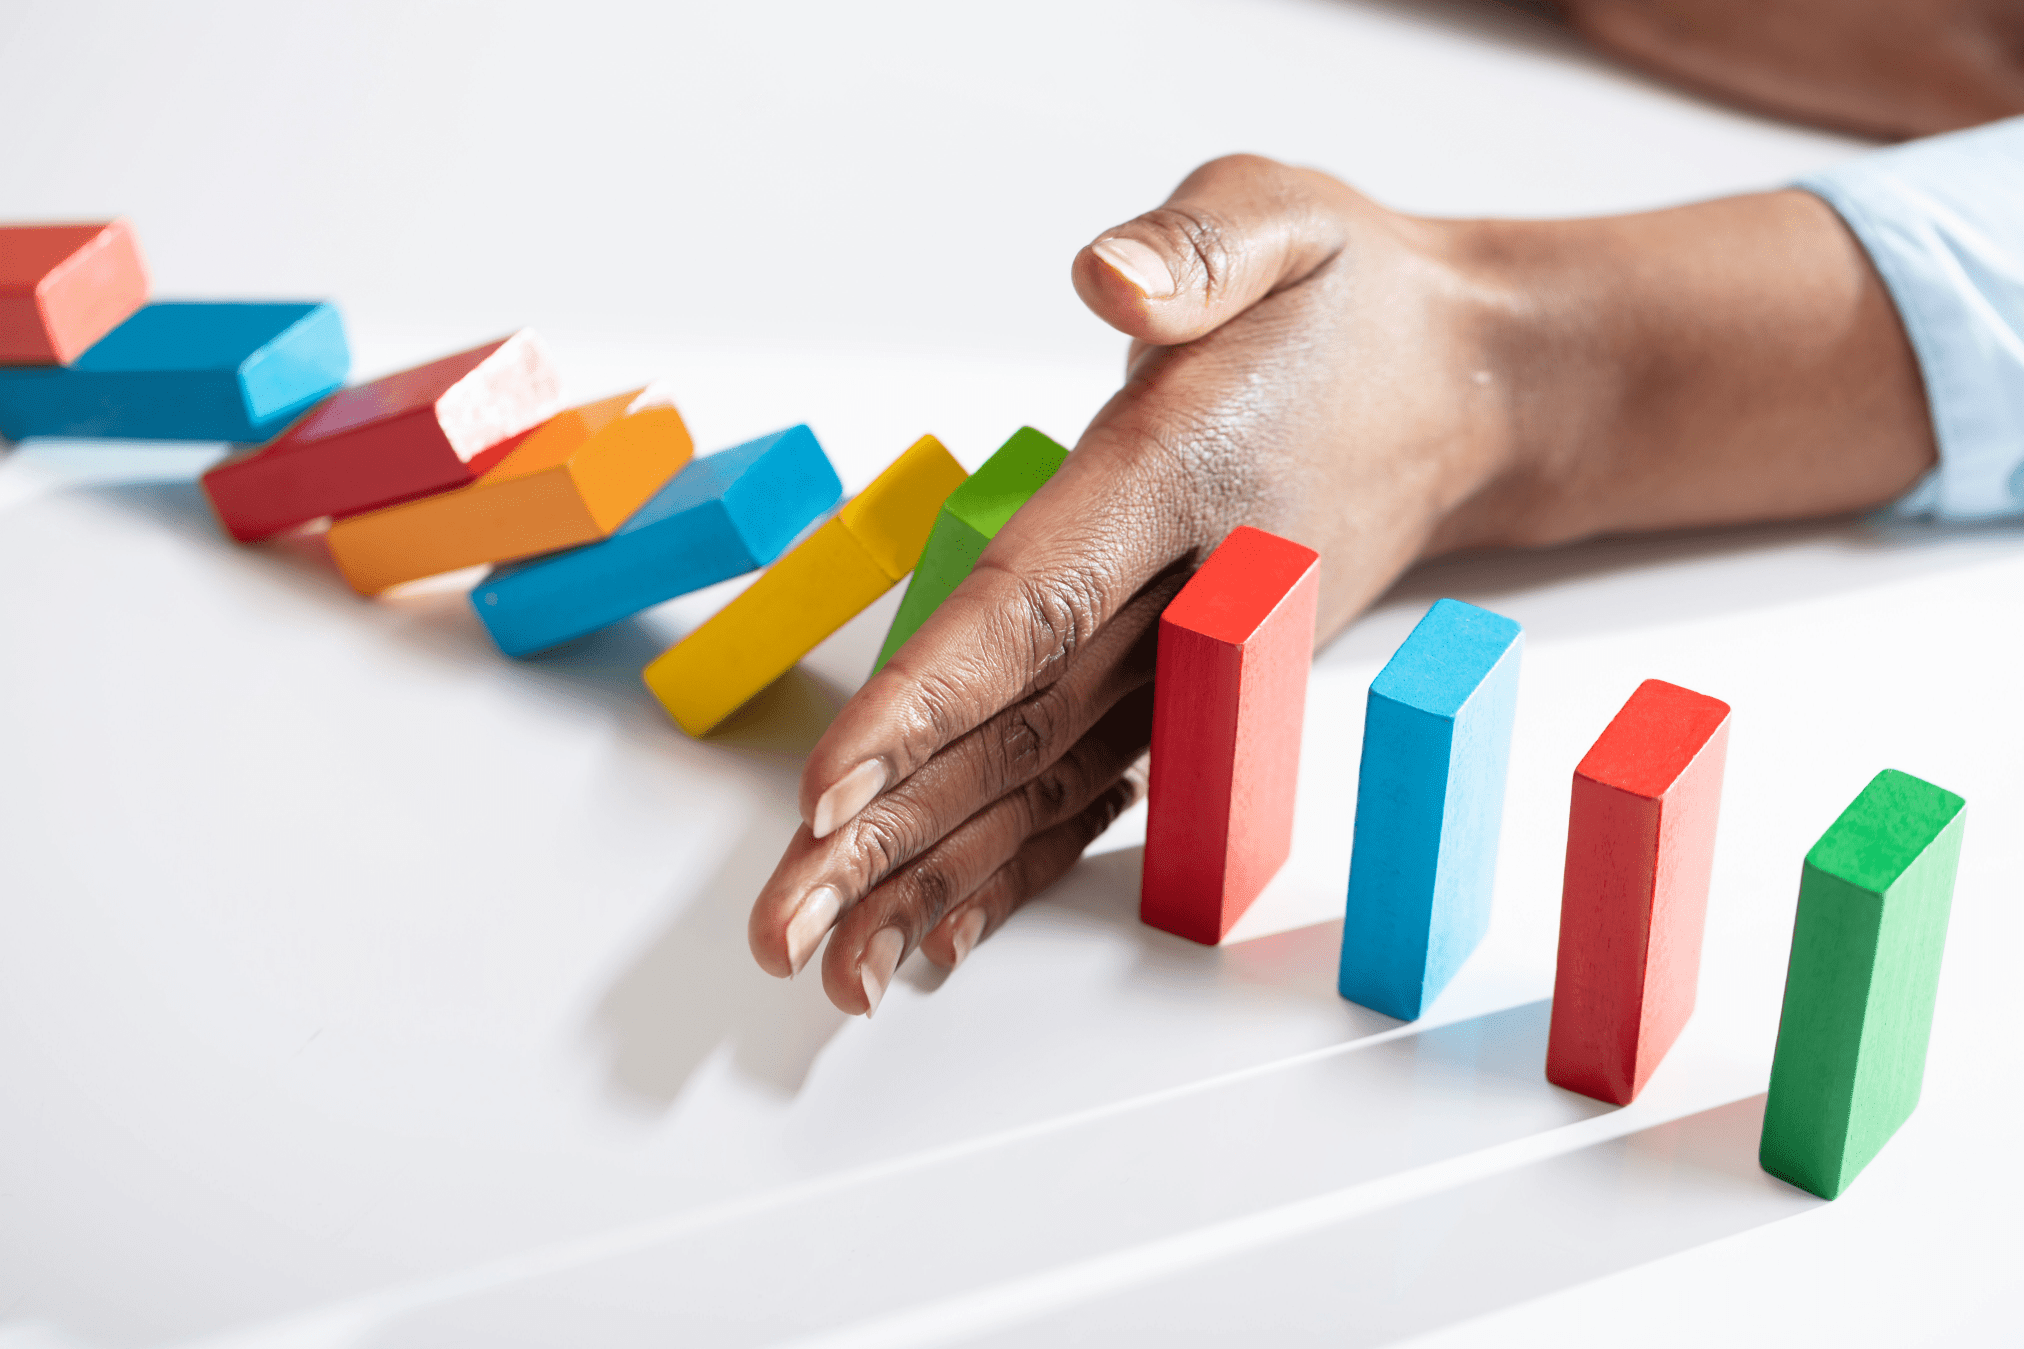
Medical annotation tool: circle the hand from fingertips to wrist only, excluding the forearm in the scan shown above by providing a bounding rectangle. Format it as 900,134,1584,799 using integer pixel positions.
751,158,1508,1011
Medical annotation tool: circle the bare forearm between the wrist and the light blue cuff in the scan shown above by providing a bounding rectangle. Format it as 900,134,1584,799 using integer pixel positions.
1427,190,1935,552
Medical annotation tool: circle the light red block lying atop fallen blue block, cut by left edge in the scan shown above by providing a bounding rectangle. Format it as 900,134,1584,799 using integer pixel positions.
0,220,148,366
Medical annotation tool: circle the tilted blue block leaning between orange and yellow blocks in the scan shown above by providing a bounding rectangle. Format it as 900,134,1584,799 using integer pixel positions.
472,418,844,655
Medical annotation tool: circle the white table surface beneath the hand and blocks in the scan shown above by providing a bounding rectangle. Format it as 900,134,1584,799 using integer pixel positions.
0,0,2024,1349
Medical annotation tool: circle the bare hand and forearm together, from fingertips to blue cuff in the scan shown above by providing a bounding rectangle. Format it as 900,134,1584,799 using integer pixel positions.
749,156,1933,1013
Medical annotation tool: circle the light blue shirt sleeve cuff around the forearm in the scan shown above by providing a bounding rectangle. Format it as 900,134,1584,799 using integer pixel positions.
1797,117,2024,520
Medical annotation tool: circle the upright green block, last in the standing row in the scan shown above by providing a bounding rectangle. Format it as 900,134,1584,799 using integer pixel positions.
1757,769,1965,1199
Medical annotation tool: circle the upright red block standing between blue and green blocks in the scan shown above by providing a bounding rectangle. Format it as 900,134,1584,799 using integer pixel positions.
1546,680,1728,1106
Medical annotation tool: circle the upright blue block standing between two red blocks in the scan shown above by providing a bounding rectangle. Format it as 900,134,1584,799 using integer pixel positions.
1336,599,1524,1021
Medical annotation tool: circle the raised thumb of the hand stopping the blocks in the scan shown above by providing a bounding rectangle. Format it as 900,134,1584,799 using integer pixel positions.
1073,156,1348,346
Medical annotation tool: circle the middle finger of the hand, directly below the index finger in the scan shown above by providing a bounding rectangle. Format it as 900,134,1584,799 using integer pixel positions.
749,572,1182,975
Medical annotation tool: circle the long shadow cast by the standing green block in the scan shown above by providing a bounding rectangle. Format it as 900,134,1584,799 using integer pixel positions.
951,1094,1822,1349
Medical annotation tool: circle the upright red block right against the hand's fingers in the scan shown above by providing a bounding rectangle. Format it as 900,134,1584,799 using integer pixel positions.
1140,526,1322,947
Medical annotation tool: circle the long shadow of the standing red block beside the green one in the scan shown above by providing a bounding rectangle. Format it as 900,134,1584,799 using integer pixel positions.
352,1003,1609,1349
